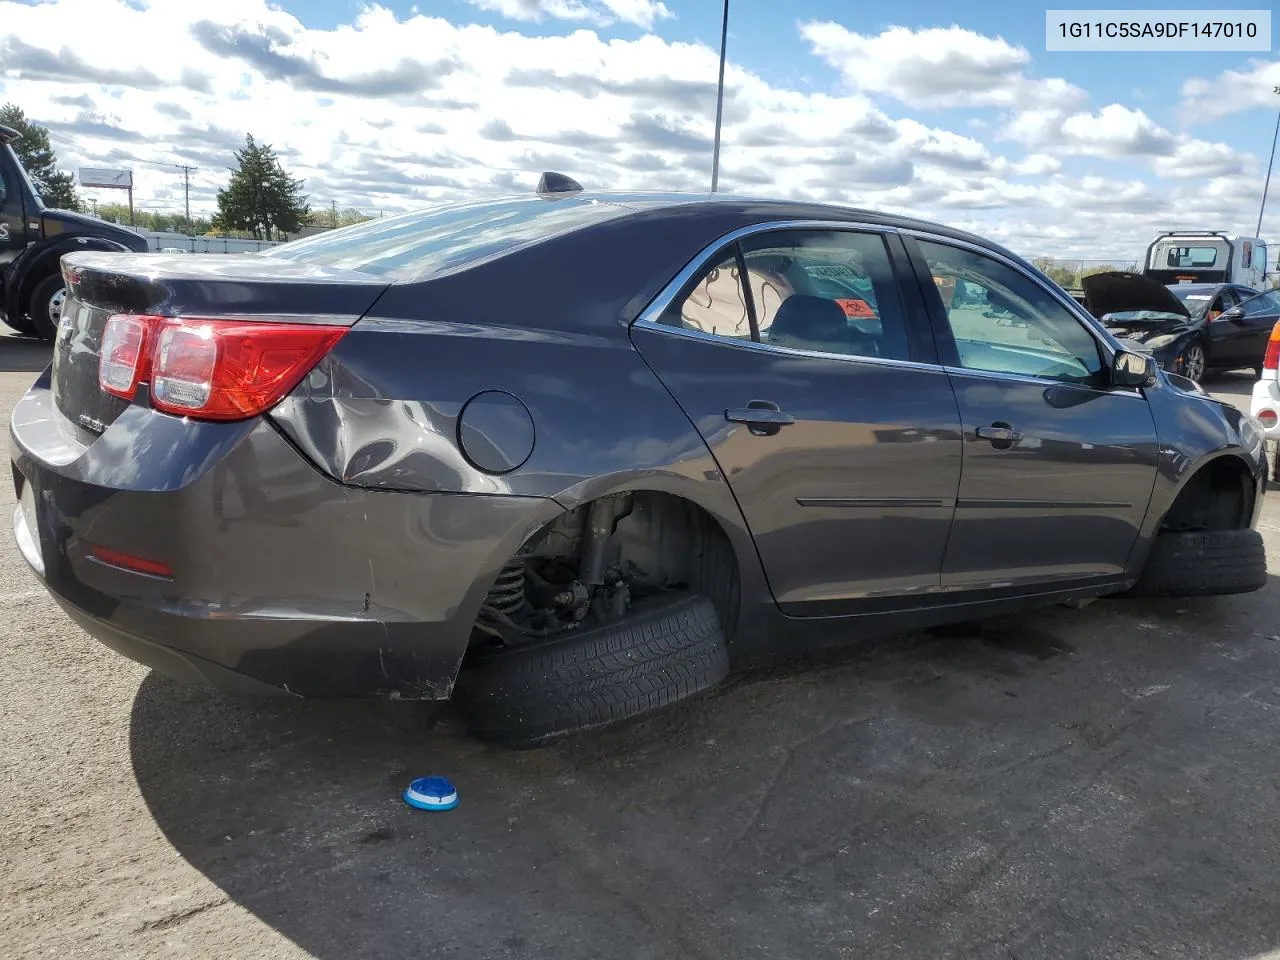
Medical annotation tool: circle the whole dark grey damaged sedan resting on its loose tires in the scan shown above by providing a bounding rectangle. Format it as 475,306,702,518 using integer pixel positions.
10,188,1266,742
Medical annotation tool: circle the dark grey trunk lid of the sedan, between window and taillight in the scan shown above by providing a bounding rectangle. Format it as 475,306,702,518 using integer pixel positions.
52,253,388,444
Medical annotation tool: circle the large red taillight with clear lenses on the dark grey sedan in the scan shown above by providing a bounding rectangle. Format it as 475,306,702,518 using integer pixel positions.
99,316,346,420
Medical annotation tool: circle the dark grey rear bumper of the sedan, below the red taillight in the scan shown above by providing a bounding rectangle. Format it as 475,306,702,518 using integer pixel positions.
10,372,561,699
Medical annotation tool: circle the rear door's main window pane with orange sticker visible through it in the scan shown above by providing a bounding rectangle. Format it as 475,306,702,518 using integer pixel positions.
741,230,910,360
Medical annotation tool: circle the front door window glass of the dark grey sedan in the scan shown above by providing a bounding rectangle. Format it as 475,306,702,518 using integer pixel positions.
919,241,1102,383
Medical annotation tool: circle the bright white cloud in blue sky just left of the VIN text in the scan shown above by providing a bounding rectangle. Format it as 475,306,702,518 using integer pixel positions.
800,20,1084,108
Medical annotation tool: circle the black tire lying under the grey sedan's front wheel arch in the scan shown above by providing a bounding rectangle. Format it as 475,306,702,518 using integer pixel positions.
1129,530,1267,596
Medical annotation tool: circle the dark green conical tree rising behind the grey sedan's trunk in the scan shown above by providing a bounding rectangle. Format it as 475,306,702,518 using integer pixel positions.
214,133,311,239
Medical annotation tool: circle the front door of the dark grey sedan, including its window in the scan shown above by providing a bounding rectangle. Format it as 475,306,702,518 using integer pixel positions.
909,239,1157,591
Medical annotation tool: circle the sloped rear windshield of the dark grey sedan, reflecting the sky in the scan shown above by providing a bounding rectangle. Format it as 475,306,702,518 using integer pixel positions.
262,197,631,280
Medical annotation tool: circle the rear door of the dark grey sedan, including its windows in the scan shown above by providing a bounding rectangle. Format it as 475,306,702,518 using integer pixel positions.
631,228,960,616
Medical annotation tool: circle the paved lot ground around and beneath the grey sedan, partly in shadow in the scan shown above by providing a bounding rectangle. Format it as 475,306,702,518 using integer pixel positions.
0,338,1280,960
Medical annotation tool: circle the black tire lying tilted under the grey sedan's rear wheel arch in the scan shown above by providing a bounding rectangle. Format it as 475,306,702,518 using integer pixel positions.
454,594,728,746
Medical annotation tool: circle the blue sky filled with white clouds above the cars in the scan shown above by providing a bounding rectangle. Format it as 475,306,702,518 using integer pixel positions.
0,0,1280,259
